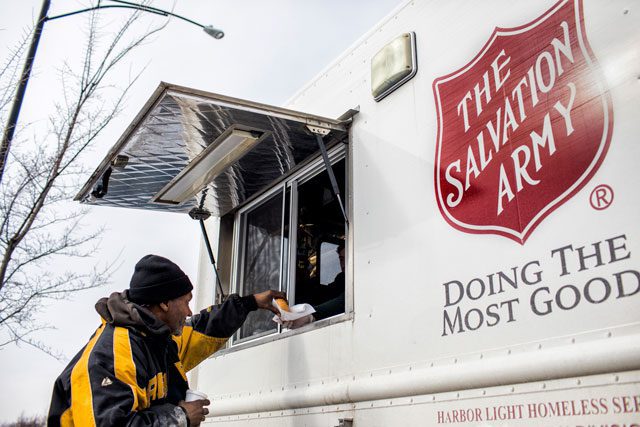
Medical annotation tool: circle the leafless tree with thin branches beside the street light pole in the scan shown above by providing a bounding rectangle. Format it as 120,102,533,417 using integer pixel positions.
0,1,167,357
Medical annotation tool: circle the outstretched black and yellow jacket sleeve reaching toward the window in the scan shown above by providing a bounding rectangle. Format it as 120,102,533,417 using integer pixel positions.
173,294,258,372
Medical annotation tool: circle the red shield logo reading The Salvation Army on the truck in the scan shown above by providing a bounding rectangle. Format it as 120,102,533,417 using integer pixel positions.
433,0,613,244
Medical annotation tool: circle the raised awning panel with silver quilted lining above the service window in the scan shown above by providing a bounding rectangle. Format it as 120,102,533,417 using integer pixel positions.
75,83,347,216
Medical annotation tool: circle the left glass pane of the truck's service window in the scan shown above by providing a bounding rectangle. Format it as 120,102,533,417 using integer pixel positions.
238,193,282,339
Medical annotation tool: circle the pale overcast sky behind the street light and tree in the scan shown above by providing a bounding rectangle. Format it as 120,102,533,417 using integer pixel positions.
0,0,403,422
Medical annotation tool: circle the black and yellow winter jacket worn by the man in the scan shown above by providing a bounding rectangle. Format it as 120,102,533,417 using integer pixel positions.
47,291,257,427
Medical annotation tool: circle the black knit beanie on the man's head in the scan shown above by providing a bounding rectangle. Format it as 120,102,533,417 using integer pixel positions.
128,255,193,304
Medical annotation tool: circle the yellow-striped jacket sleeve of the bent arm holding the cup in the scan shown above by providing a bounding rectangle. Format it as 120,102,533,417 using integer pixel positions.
66,328,188,427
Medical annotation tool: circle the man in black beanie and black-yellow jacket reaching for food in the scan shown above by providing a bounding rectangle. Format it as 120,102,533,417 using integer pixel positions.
47,255,285,427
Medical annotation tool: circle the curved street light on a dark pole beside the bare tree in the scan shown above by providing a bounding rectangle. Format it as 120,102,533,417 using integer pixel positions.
0,0,224,183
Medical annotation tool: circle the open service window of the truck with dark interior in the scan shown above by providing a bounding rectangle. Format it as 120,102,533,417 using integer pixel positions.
234,147,347,343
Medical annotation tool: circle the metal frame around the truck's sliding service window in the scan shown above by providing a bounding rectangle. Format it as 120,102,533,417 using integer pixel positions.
228,144,353,348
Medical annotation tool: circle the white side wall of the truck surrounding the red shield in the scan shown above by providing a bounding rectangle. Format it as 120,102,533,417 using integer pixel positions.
197,0,640,426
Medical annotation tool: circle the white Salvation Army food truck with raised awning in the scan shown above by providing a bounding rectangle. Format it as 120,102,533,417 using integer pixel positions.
78,0,640,427
